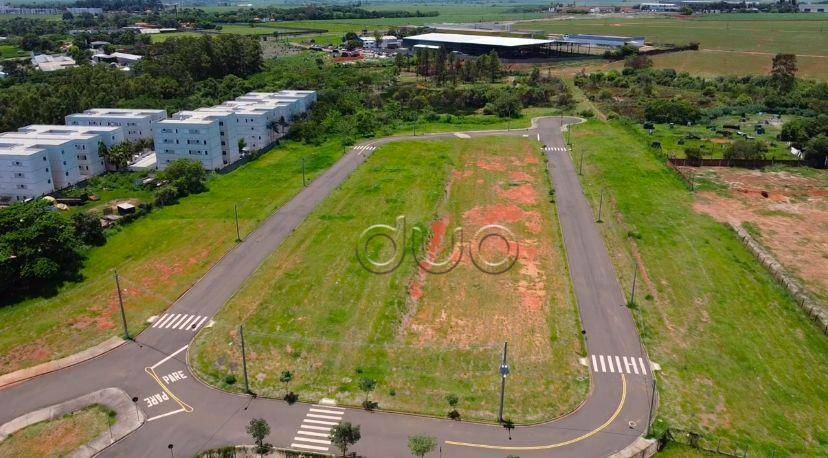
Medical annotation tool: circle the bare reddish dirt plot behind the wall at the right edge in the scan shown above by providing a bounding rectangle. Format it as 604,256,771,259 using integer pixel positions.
694,168,828,303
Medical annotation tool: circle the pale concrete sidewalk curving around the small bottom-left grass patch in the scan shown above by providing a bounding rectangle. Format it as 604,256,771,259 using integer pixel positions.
0,388,145,457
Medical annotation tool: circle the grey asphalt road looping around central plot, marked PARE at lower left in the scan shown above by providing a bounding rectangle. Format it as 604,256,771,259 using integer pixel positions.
0,118,652,457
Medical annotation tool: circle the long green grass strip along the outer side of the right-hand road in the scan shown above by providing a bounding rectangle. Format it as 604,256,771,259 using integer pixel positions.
574,121,828,456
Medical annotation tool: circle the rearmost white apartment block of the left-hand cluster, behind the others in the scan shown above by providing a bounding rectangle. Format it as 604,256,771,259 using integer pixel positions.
66,108,167,141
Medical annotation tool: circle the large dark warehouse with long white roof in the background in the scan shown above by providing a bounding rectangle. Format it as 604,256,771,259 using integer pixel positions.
403,33,552,59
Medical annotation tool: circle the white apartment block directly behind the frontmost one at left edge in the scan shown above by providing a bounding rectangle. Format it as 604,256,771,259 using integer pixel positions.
0,136,83,189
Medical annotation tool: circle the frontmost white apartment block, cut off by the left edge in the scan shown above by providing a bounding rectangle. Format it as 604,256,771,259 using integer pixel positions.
0,141,55,202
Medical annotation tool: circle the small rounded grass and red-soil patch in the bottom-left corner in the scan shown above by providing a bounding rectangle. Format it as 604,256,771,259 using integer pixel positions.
0,406,111,457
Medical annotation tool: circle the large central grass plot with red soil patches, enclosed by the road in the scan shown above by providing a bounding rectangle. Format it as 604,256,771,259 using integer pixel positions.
190,137,588,422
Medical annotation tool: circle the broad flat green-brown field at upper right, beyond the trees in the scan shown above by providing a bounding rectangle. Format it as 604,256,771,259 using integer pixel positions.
519,14,828,80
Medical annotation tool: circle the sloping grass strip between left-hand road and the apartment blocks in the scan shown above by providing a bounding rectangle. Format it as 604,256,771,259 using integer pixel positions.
0,142,343,373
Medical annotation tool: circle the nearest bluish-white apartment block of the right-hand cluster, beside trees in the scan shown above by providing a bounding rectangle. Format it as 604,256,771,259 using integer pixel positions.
155,111,225,170
